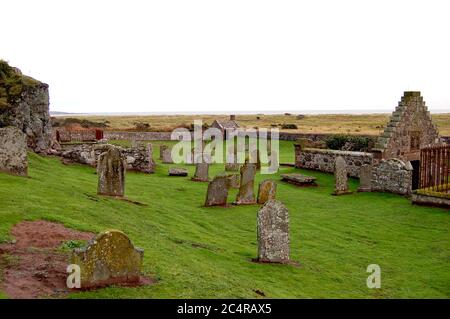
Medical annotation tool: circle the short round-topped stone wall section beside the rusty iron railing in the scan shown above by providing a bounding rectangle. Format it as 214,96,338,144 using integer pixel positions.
371,158,413,195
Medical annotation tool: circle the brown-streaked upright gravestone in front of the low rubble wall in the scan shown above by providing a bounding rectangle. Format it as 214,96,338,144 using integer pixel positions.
97,146,125,196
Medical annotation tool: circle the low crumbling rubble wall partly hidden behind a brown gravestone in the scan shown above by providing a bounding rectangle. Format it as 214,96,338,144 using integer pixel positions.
61,144,155,173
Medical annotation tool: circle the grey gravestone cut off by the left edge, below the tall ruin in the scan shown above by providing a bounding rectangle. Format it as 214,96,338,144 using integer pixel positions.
0,126,28,176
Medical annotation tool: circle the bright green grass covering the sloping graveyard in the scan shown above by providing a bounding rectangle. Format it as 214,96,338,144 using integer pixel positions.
0,142,450,298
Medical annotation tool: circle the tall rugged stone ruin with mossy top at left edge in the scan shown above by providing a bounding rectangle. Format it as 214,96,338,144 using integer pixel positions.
0,60,52,153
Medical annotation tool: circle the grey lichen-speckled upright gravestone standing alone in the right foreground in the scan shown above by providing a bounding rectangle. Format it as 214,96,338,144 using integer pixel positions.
257,200,289,263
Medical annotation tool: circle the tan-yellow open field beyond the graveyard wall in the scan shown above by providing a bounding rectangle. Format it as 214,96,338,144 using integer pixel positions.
58,113,450,135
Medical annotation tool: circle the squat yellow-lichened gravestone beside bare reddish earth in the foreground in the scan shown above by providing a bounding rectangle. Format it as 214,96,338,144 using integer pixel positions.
71,230,144,289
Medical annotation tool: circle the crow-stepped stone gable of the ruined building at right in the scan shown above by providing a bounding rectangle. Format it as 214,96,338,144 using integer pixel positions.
374,92,439,161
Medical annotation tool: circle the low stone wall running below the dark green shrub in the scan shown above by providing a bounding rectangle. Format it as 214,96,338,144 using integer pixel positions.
295,145,372,177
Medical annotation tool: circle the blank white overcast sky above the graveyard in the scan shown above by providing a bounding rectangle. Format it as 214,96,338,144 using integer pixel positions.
0,0,450,113
